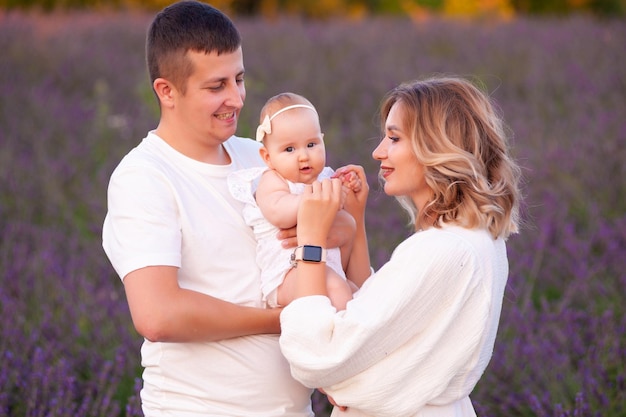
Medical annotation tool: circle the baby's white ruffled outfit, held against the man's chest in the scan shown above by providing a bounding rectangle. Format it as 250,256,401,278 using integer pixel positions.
228,167,346,307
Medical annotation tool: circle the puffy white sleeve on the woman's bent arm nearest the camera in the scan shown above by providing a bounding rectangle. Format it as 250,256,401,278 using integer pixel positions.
280,231,484,401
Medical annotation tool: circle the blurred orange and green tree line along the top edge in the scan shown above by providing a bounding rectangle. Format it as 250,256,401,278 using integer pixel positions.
0,0,626,18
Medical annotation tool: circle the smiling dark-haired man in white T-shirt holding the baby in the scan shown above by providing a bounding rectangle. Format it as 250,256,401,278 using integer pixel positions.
103,1,349,417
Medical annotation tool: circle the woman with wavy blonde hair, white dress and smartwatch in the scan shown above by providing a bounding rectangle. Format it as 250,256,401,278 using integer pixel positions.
280,77,520,417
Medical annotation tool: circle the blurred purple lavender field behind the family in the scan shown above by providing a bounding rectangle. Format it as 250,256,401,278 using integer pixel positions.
0,12,626,417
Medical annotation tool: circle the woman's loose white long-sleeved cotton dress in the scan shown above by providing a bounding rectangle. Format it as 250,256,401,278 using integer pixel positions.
280,226,508,417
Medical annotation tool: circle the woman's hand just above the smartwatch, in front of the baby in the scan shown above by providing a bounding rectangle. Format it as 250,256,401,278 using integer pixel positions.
297,178,342,247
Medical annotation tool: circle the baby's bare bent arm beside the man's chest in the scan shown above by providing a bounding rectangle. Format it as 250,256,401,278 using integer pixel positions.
255,170,300,229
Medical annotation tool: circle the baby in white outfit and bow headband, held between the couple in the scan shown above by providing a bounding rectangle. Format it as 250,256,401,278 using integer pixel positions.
228,93,361,310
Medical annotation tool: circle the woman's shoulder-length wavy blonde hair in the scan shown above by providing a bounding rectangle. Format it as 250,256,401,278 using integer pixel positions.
381,77,521,239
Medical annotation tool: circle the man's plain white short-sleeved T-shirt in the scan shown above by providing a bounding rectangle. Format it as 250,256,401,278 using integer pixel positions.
103,132,313,417
